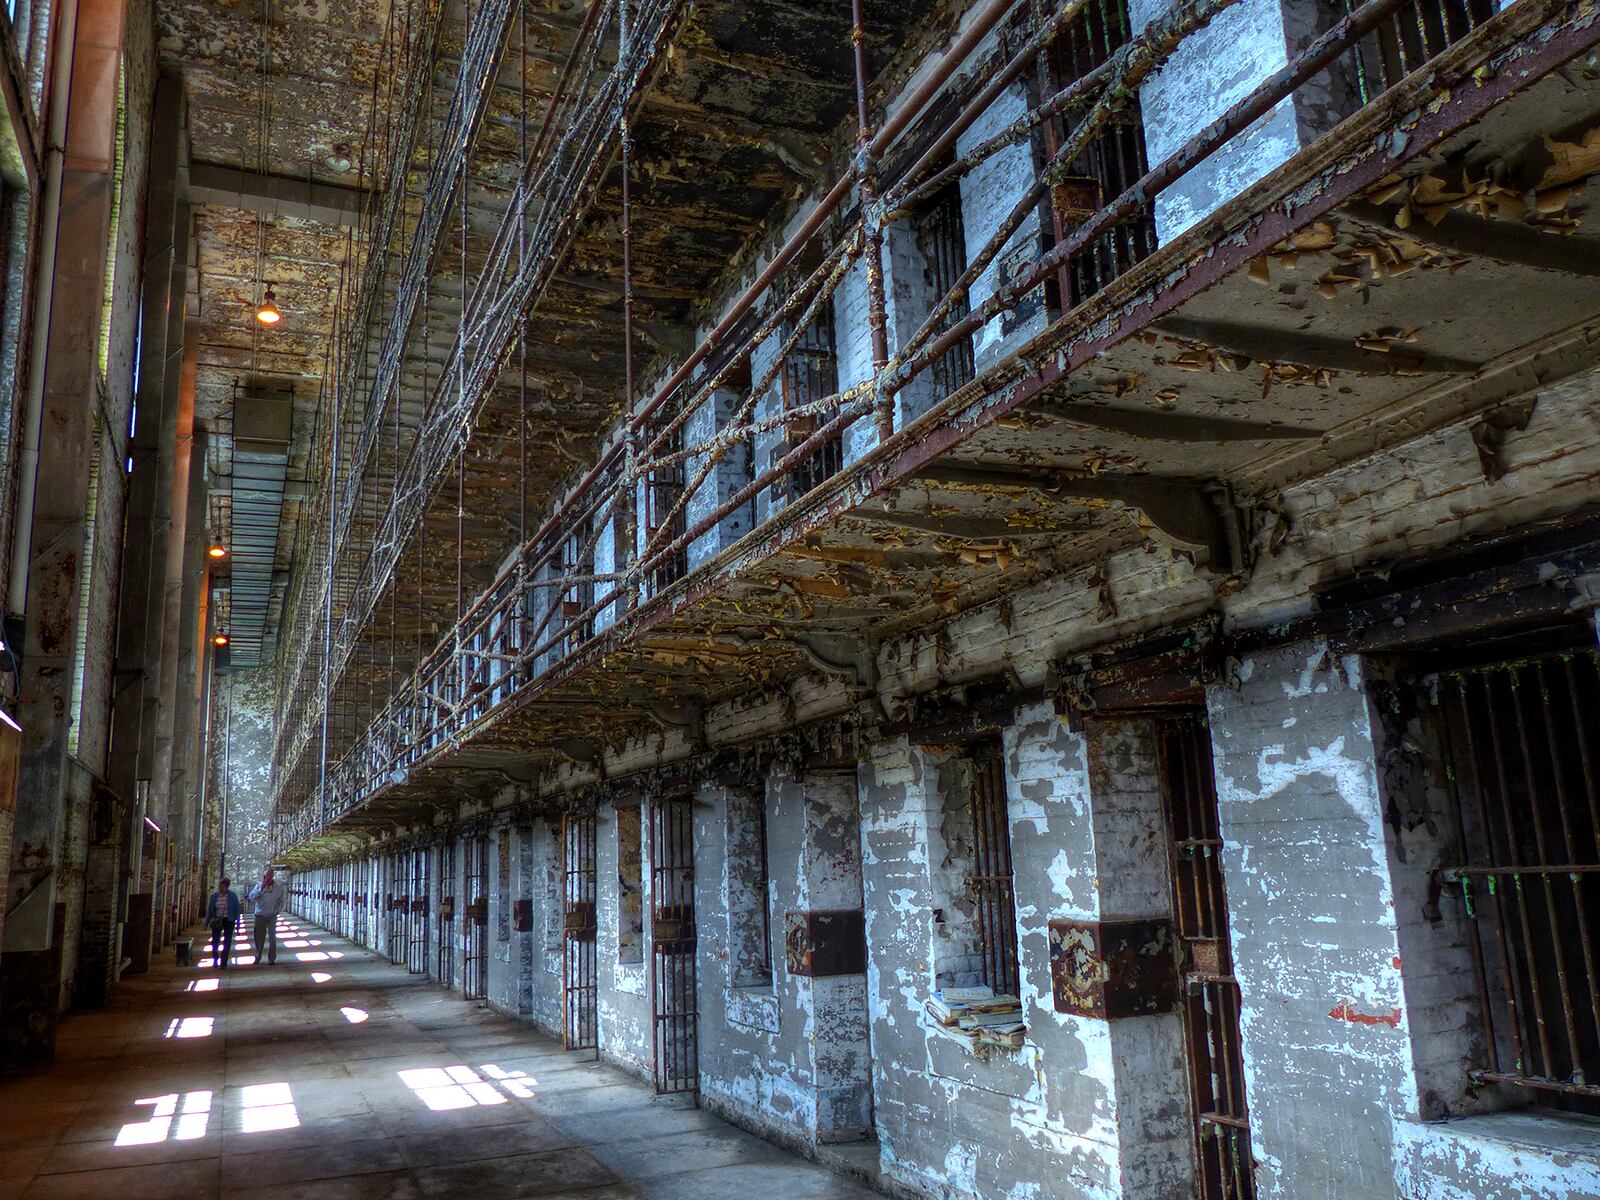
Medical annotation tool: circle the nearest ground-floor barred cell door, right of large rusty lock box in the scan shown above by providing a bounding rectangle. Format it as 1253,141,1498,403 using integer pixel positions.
1157,712,1256,1200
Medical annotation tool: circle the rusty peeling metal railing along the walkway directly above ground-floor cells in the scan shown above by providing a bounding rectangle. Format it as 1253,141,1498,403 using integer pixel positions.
272,0,1548,834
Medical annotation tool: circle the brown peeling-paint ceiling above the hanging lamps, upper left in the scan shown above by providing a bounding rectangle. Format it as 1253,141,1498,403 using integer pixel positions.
155,0,410,668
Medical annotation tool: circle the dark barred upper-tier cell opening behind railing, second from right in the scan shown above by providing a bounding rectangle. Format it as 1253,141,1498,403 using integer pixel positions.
1043,0,1155,307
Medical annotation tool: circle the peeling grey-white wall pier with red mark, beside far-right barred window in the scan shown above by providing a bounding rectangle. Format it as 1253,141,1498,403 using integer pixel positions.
1208,643,1419,1200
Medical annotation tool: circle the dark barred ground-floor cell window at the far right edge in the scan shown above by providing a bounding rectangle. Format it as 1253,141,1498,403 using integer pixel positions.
1440,650,1600,1115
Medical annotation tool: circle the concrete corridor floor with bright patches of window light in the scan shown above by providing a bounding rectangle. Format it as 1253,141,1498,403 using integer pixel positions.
0,920,877,1200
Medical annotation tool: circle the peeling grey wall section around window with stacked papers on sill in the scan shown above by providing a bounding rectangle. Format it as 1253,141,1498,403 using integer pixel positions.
859,704,1192,1200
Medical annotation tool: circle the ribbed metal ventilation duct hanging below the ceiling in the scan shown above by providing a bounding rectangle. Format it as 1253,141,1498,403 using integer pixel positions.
227,392,294,667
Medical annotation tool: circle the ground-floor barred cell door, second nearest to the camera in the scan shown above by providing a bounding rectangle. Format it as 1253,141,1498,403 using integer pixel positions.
650,798,699,1093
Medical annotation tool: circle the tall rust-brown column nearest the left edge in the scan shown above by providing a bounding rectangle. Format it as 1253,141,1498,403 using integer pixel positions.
0,0,123,1062
